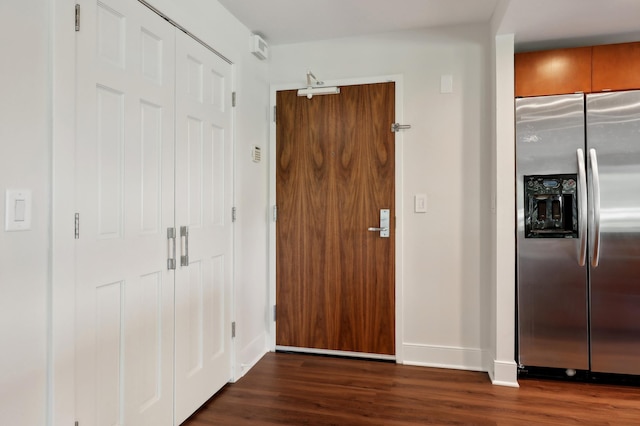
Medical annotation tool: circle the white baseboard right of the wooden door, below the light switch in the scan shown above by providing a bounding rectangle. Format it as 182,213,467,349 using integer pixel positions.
402,343,486,371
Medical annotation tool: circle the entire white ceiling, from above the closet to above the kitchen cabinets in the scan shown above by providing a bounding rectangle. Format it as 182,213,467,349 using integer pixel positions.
218,0,640,50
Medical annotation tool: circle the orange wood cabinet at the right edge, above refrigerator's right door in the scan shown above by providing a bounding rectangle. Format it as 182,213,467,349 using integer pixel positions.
592,42,640,92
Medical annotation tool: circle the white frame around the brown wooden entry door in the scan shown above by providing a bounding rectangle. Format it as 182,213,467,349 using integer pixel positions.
268,74,404,364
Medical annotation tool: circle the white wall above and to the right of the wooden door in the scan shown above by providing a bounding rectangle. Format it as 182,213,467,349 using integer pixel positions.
269,25,491,370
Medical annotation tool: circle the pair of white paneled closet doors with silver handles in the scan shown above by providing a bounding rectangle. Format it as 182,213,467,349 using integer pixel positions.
75,0,233,426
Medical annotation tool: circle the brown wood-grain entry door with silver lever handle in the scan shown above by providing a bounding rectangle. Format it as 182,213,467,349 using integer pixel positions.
276,83,395,355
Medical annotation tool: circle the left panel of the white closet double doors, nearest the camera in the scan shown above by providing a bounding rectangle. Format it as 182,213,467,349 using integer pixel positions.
70,0,175,426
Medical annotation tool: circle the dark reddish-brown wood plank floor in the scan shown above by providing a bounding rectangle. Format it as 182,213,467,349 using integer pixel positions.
183,353,640,426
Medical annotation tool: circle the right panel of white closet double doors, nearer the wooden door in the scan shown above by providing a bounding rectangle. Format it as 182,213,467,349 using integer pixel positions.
175,31,233,424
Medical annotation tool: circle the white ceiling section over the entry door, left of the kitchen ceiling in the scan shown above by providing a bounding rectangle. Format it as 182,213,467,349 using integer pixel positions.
219,0,498,45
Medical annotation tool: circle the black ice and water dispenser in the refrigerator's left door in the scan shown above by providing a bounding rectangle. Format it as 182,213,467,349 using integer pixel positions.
524,174,578,238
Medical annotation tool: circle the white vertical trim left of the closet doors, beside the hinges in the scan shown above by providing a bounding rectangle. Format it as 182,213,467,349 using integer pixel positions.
47,0,76,425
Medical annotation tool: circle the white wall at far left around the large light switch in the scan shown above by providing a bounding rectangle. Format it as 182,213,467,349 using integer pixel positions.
0,0,51,425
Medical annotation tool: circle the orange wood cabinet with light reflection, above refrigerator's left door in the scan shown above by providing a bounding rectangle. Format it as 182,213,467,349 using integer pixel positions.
515,47,592,97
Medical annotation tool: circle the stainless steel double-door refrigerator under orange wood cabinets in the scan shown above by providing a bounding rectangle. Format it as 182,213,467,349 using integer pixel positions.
516,91,640,375
